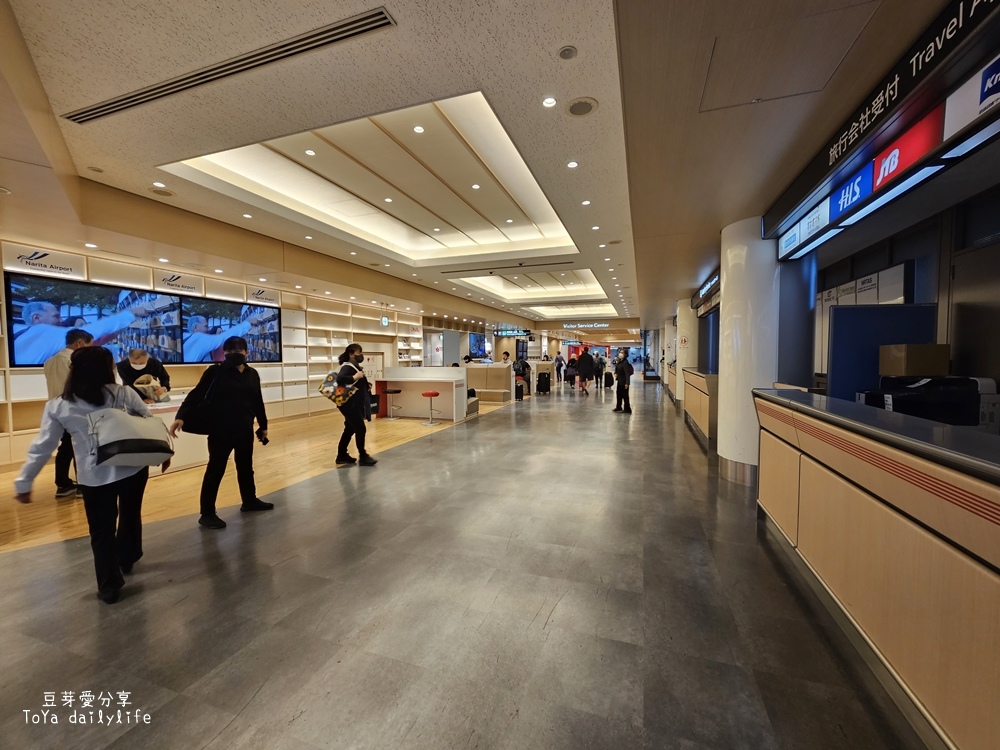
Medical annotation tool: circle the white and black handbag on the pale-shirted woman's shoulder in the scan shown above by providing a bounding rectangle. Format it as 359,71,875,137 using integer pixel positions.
87,387,174,466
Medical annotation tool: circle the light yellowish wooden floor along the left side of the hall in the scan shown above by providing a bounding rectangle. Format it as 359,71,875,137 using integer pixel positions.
0,403,509,553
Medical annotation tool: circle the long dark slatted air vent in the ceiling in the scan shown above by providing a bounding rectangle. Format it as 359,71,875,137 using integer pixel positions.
63,8,396,125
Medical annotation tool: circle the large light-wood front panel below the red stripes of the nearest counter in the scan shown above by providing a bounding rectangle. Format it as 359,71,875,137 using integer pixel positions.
798,457,1000,750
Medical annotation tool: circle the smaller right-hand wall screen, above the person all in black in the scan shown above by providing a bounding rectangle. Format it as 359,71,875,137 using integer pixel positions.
181,297,281,364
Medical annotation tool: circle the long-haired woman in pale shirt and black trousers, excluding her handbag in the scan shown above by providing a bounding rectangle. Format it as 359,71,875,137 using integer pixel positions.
14,346,170,604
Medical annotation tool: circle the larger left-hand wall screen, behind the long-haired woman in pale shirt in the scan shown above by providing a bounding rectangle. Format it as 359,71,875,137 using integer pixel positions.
5,273,183,367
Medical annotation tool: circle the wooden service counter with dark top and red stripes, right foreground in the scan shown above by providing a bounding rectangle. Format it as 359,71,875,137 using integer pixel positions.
754,389,1000,750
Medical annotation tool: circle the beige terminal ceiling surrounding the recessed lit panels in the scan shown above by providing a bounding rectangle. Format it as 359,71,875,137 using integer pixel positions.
4,0,960,328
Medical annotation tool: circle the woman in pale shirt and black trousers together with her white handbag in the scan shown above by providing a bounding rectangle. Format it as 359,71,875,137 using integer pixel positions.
14,346,173,604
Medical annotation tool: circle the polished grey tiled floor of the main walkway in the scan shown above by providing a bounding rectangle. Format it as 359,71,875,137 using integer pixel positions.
0,383,915,750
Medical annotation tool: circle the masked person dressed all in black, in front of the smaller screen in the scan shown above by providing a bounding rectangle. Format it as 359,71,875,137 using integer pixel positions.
170,336,274,529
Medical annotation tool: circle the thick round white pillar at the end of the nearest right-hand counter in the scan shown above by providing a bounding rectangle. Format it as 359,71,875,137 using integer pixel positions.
717,217,780,484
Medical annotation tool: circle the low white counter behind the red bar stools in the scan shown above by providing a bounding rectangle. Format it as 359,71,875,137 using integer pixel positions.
375,367,478,422
